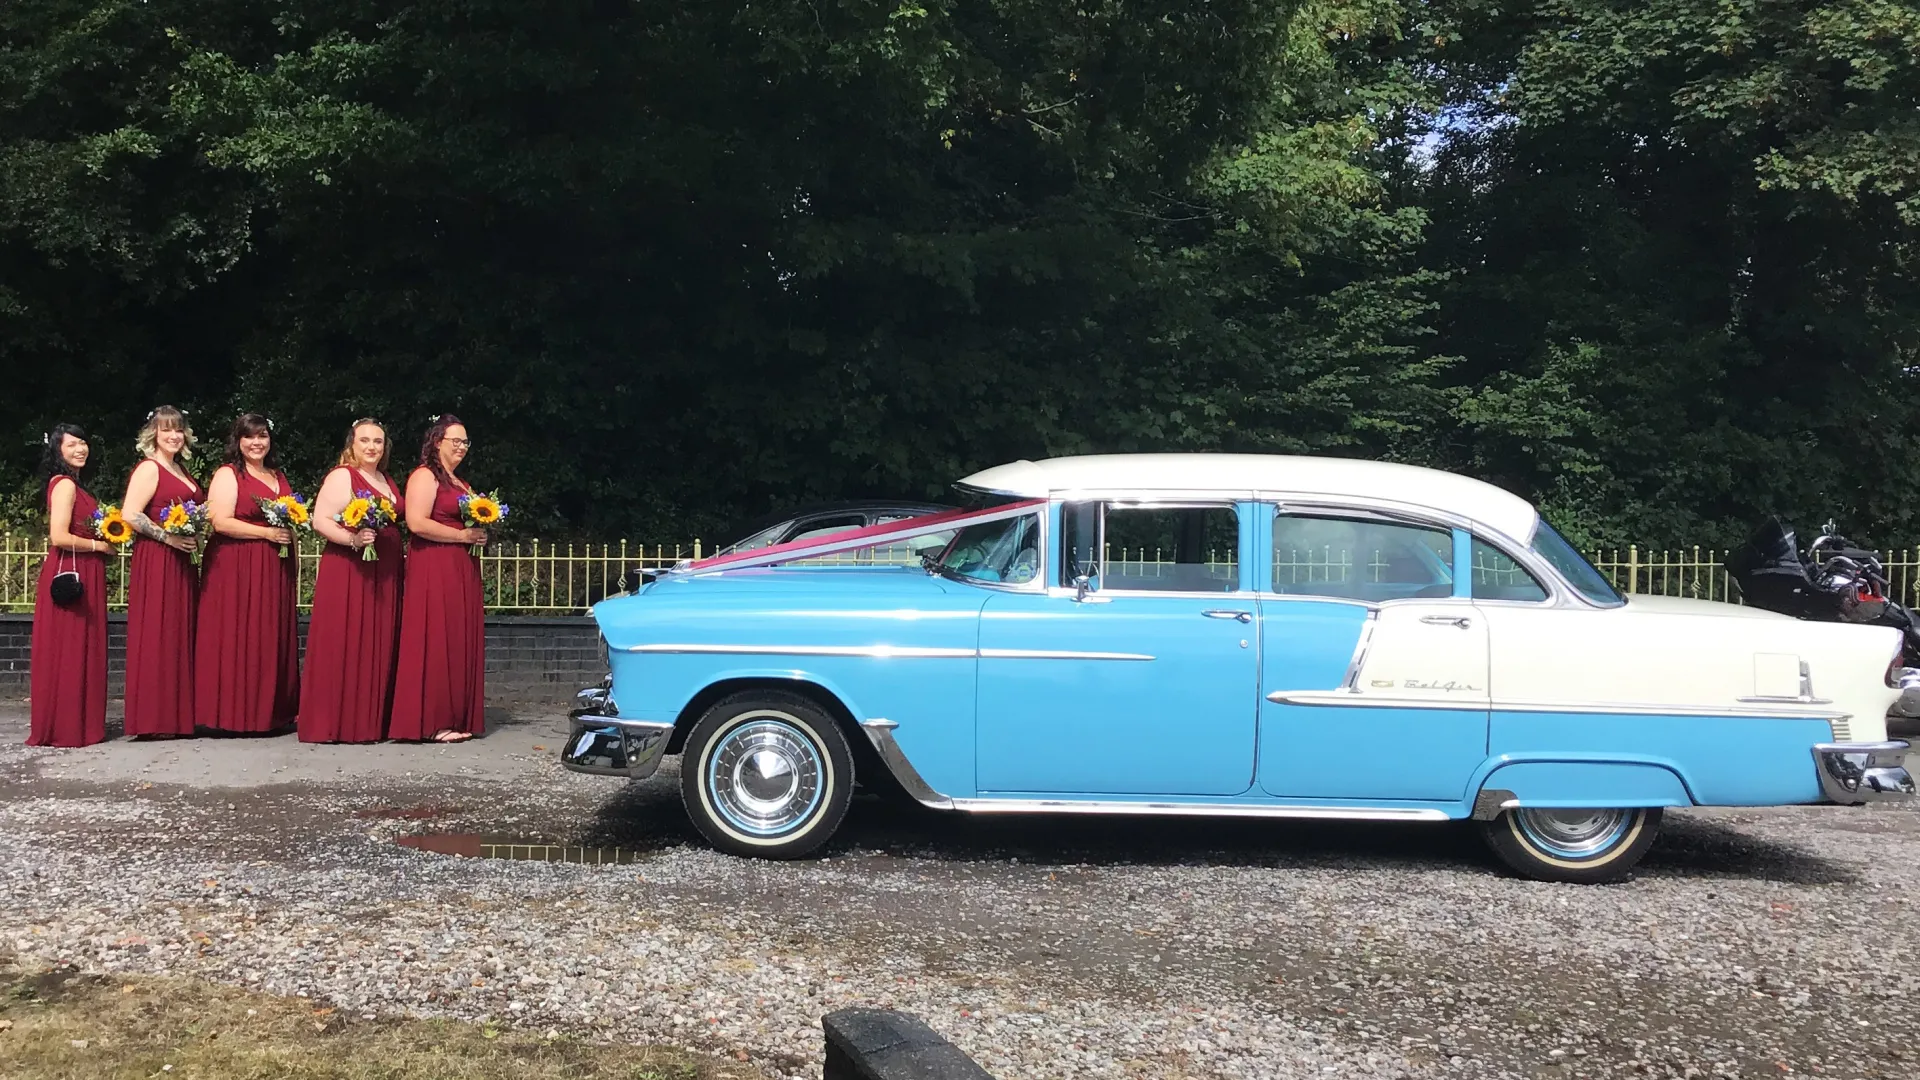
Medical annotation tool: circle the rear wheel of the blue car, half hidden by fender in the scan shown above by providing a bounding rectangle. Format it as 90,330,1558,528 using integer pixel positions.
1480,807,1661,884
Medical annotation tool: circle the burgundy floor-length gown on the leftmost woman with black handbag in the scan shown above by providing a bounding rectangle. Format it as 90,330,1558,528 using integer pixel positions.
27,477,108,746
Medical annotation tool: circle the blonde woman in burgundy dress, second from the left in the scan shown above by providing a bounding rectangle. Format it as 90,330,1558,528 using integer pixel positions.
121,405,207,738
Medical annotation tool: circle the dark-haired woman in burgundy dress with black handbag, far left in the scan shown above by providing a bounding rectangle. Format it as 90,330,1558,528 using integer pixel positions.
27,425,109,746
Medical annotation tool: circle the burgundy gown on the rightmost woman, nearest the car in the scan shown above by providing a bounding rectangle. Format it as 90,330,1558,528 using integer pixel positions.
388,470,486,740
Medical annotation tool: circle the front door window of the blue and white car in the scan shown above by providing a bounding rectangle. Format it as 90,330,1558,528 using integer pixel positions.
1105,505,1240,592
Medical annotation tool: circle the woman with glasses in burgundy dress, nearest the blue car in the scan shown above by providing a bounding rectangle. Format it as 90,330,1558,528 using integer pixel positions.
388,415,486,742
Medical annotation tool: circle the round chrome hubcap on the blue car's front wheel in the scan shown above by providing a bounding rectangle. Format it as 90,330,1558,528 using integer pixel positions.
707,713,826,836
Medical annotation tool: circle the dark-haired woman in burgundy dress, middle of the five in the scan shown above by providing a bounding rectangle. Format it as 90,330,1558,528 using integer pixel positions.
194,413,300,734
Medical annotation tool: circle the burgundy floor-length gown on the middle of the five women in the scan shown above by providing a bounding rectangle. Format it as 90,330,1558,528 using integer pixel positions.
194,465,300,734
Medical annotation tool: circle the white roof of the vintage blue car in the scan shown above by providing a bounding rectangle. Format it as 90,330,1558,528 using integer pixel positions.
958,454,1540,542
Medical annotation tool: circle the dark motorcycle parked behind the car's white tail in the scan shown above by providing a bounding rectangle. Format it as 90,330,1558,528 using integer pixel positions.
1724,517,1920,715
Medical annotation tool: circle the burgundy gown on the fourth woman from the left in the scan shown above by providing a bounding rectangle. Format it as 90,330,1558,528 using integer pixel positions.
300,465,407,742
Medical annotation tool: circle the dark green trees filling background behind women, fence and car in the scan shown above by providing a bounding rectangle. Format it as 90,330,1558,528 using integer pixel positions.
0,0,1920,544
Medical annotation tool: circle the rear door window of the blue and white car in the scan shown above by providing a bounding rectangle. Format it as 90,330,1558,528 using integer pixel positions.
1273,511,1453,603
